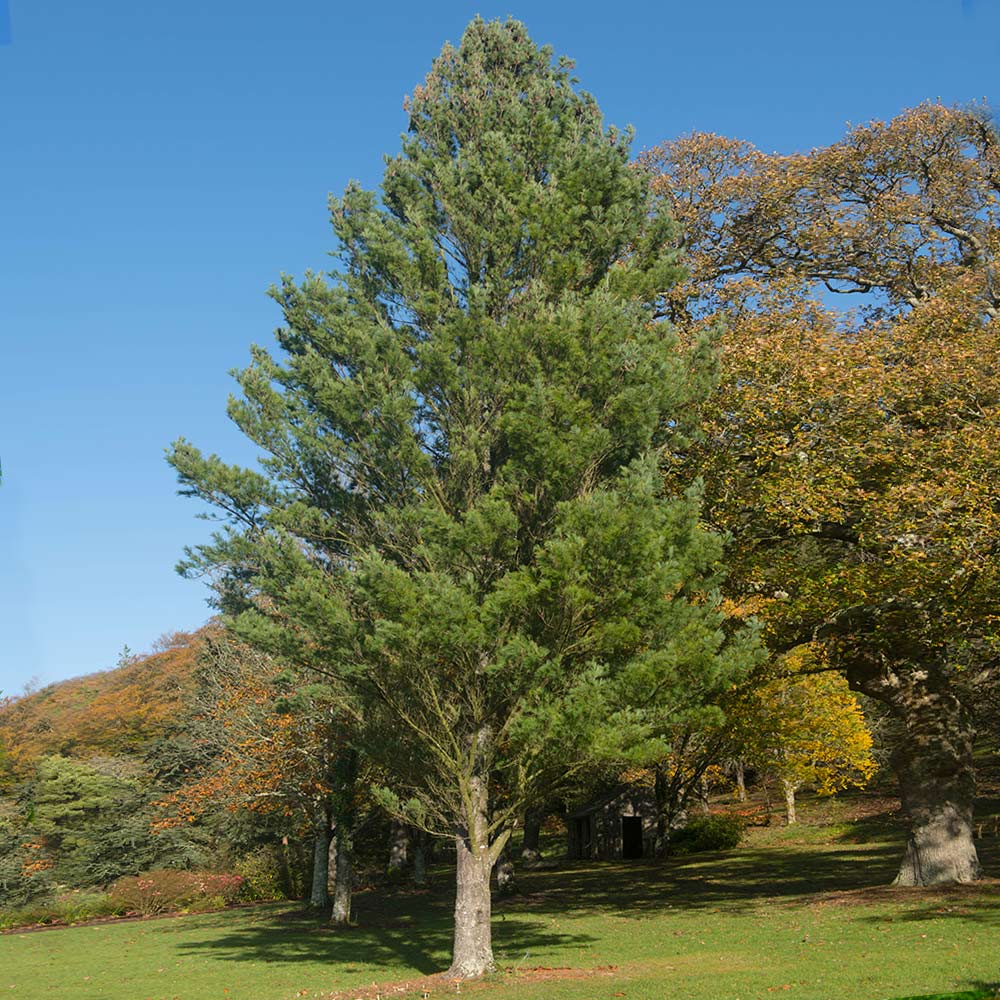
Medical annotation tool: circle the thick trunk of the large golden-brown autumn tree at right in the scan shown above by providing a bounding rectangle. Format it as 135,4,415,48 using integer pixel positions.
847,657,981,885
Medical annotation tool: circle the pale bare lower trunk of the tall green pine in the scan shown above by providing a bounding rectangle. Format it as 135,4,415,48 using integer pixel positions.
445,776,494,979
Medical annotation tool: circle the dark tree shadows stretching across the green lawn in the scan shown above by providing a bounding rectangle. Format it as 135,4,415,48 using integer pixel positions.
179,843,1000,974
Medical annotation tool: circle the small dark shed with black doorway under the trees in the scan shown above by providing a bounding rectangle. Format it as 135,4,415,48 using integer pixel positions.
567,785,656,861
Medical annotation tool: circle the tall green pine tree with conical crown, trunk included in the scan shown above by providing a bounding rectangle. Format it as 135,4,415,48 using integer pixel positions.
171,19,752,978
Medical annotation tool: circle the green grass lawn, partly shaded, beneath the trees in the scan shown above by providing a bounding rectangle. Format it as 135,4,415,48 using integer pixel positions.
0,806,1000,1000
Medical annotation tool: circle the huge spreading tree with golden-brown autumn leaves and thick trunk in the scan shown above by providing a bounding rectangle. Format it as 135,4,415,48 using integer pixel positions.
646,105,1000,884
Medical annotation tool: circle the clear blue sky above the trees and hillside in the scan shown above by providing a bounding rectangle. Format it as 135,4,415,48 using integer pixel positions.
0,0,1000,691
